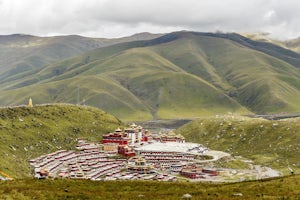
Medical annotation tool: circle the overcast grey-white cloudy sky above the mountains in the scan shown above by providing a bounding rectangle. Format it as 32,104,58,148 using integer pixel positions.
0,0,300,39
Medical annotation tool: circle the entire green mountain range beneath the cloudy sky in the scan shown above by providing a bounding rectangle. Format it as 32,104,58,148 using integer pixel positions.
0,31,300,120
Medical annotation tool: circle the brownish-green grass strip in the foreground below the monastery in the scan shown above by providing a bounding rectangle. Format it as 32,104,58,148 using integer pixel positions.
0,175,300,200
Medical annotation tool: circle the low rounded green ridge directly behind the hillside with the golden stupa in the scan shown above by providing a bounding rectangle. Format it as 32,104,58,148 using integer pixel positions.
1,76,151,120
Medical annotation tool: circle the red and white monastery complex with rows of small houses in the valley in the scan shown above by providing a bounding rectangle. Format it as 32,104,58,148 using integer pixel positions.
30,124,278,181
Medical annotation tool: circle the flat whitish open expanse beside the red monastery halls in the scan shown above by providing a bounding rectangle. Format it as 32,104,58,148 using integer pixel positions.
135,142,201,153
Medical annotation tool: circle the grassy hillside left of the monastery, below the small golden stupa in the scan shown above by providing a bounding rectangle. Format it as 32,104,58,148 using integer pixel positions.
0,104,122,178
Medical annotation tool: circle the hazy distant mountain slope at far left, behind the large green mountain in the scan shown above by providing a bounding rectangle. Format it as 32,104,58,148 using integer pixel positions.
0,33,161,83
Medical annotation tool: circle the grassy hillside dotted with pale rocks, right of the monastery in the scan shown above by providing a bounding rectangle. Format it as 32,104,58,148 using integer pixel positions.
177,116,300,173
